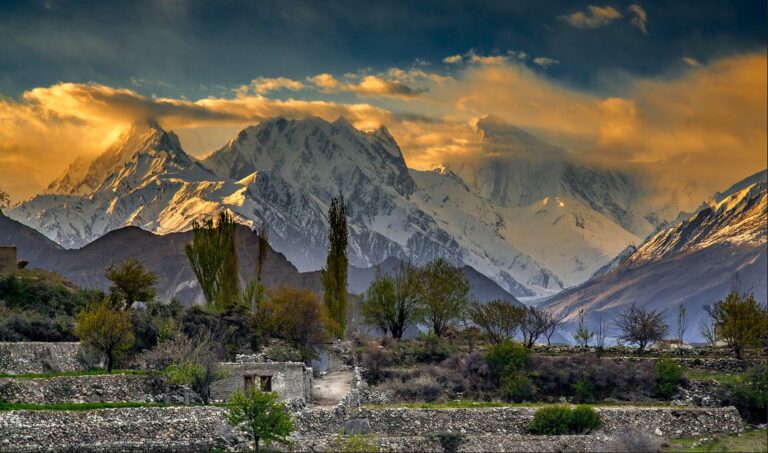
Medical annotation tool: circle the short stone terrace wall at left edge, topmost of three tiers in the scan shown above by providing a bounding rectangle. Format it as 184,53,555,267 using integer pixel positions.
0,342,91,374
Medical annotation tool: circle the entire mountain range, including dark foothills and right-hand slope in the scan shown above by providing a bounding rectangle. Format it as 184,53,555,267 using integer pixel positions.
0,116,766,342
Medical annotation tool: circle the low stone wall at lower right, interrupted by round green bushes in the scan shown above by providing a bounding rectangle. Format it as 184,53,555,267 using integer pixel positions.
295,407,744,438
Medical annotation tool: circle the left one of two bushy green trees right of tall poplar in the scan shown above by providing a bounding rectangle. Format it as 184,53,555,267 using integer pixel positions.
360,263,422,339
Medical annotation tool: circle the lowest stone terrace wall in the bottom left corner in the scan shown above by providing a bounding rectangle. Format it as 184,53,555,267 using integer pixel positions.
0,407,243,452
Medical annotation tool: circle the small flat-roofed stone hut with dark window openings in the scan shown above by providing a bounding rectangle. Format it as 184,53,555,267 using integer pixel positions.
211,362,312,406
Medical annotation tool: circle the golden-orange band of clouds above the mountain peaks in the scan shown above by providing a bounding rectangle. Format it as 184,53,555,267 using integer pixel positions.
0,52,768,208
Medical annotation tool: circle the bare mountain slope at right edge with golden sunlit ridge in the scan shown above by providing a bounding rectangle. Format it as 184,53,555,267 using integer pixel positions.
543,172,768,340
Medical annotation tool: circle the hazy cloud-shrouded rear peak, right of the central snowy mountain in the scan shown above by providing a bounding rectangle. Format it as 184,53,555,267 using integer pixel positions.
451,116,653,238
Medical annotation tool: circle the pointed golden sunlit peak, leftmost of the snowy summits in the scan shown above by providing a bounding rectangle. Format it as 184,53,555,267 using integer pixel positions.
47,120,194,195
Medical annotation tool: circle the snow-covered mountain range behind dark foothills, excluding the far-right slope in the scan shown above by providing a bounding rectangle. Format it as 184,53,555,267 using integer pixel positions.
8,117,672,297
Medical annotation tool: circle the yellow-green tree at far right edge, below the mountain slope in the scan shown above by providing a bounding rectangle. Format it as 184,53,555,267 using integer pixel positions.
704,287,768,359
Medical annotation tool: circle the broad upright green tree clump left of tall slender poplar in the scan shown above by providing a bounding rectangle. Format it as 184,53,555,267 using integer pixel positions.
184,211,241,310
